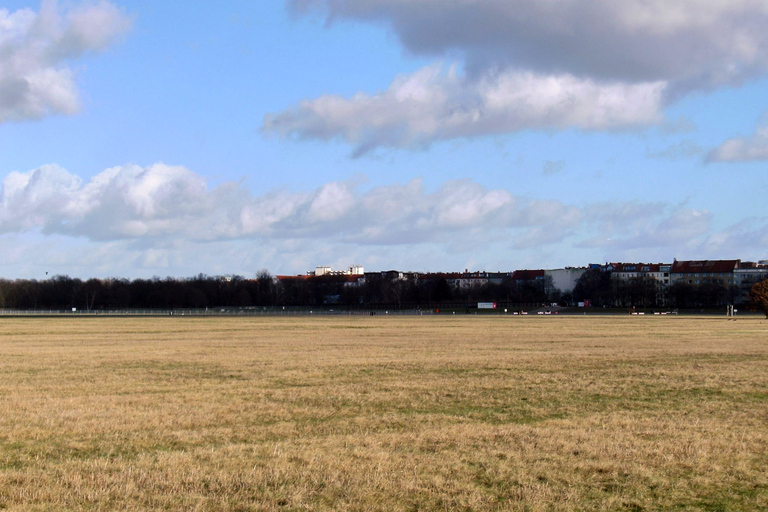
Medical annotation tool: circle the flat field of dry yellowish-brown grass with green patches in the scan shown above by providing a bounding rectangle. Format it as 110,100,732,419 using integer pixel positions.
0,316,768,511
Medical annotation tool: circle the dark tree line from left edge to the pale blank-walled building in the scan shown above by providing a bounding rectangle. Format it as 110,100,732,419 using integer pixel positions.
0,270,554,311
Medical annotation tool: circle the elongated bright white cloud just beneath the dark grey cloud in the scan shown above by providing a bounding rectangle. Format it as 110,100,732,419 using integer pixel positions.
263,66,665,156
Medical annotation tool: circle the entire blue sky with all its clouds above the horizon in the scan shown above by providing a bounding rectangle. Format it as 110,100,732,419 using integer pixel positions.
0,0,768,279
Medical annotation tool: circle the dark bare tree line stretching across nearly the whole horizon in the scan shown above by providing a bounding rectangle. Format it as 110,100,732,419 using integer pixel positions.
0,269,764,311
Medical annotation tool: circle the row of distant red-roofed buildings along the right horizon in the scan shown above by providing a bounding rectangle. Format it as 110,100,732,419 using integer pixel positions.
278,260,768,307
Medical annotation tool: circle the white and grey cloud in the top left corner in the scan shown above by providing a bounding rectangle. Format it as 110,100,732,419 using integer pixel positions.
0,0,131,122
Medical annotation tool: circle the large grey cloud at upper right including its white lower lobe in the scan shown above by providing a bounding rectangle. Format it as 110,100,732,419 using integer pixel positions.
272,0,768,155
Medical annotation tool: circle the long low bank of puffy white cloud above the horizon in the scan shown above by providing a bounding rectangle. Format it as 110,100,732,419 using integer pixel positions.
0,164,732,261
